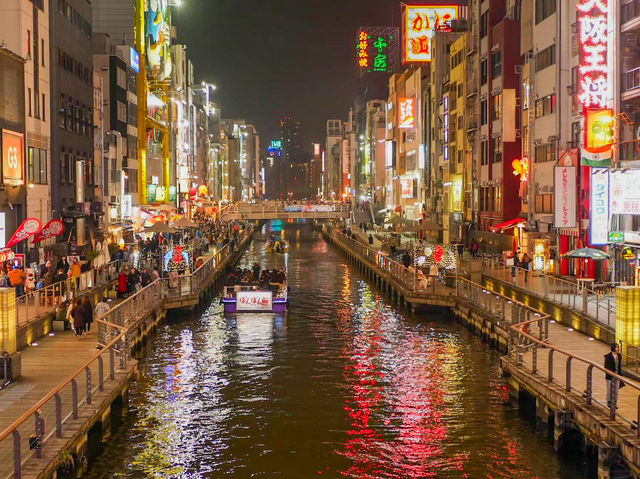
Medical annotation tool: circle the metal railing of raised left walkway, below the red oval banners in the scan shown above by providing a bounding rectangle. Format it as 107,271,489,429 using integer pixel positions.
16,261,122,326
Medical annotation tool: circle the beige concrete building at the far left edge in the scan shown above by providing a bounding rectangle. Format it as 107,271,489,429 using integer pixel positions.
0,0,52,261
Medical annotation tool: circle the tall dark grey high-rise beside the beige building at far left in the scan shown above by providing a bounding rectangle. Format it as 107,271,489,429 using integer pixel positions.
49,0,97,246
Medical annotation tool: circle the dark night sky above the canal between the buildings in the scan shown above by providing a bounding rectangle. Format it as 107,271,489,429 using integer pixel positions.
173,0,400,150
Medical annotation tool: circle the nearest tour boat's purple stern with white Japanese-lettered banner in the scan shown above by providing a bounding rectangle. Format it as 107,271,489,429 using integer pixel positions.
222,281,289,313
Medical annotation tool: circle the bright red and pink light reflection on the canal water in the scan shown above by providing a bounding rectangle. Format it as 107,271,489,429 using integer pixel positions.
338,304,465,479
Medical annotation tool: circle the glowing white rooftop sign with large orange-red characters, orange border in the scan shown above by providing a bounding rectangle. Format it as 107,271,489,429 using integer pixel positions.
404,5,458,63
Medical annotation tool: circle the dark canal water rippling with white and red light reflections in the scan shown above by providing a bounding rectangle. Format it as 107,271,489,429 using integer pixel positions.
88,224,586,479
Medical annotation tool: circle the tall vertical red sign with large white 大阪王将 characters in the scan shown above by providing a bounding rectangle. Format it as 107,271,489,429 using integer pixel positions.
577,0,609,108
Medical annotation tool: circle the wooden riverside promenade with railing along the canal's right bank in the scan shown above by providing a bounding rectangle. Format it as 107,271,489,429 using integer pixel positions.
324,228,640,479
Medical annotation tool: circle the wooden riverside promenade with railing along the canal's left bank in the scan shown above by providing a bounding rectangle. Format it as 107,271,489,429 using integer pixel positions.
0,227,253,479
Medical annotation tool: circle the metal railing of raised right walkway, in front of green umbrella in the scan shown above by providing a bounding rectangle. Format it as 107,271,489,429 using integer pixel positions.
482,256,616,331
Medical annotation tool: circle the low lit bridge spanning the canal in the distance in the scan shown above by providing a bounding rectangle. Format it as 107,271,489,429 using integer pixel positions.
220,202,351,221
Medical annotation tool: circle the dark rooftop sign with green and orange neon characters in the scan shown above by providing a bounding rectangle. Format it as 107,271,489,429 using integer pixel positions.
356,27,399,73
